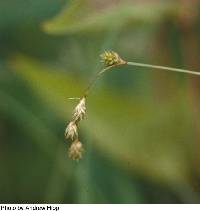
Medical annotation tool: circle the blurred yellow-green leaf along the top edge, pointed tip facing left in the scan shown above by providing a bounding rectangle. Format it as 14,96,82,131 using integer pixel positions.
43,0,178,34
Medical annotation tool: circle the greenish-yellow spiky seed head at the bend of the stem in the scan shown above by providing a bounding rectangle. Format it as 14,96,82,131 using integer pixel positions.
100,51,126,67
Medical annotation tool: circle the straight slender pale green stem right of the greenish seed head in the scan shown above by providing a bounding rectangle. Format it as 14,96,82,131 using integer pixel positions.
126,62,200,75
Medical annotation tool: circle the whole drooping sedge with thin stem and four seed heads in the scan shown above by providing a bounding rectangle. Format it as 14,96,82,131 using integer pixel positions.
65,51,200,160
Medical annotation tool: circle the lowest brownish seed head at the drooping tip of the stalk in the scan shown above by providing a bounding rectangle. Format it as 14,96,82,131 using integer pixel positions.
68,139,84,160
